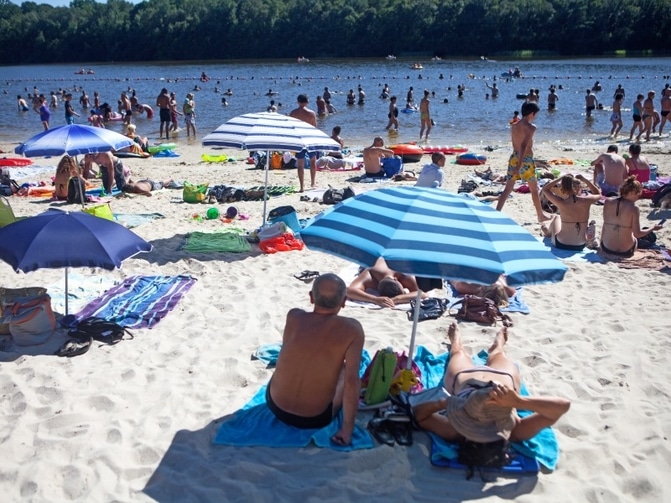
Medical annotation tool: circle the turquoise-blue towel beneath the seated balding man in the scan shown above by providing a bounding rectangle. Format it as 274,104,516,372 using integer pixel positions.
214,344,374,452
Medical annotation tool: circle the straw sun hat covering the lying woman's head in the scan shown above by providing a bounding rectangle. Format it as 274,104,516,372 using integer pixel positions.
447,387,516,443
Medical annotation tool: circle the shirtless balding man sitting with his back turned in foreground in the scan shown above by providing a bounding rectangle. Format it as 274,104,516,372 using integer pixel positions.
266,274,364,445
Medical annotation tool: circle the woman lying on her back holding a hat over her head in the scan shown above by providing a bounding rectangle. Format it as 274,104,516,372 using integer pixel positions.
413,322,571,443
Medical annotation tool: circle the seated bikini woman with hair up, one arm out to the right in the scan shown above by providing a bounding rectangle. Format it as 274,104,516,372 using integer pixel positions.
601,175,662,257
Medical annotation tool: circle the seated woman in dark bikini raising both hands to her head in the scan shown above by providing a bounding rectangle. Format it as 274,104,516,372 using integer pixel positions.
541,174,601,251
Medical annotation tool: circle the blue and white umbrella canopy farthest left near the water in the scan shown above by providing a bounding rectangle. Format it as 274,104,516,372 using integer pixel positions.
14,124,133,157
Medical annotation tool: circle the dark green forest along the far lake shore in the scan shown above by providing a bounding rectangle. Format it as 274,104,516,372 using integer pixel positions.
0,0,671,64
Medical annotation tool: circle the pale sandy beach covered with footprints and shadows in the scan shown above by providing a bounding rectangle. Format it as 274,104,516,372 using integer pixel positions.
0,134,671,502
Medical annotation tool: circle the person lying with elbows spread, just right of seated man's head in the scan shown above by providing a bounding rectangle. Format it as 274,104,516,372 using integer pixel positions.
347,257,426,307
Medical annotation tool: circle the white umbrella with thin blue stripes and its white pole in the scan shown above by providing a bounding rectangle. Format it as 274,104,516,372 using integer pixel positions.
203,112,340,224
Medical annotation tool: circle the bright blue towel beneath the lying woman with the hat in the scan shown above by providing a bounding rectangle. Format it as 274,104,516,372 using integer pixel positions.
426,346,559,470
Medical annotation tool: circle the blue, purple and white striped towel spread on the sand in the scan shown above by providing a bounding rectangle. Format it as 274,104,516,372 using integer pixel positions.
71,275,196,328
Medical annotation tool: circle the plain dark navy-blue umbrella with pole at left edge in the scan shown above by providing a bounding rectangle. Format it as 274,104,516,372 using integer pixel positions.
0,209,152,315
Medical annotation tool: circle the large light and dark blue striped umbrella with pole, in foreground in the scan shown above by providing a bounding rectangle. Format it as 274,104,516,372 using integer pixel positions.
301,187,567,368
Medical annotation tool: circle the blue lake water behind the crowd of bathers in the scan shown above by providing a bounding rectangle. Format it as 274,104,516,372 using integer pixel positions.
0,58,671,152
